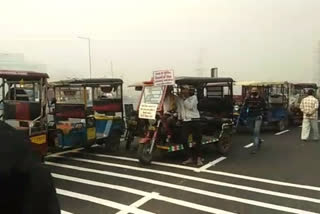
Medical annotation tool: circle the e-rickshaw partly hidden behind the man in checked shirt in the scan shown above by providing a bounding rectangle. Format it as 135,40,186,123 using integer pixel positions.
290,83,318,125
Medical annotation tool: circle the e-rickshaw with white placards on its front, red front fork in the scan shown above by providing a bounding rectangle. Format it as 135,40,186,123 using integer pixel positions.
138,77,233,164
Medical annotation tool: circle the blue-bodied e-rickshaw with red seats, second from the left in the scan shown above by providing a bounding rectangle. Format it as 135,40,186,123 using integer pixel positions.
50,79,124,149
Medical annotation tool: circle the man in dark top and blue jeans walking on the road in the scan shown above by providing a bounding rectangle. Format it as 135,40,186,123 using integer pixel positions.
244,87,266,154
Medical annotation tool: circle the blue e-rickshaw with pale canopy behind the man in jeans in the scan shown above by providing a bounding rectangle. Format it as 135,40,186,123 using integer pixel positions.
235,81,290,131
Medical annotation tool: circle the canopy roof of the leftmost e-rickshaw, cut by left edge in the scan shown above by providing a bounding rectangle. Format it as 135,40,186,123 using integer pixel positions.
0,70,49,81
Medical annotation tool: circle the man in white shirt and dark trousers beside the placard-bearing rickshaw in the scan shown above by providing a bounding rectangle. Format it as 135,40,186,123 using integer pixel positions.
181,85,203,166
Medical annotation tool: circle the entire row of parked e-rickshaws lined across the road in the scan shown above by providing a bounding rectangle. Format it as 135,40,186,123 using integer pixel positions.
0,70,317,164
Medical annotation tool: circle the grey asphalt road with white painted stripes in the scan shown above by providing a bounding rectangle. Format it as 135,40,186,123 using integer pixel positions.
46,127,320,214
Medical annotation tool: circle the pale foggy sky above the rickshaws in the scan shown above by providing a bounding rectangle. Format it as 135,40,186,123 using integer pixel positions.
0,0,320,82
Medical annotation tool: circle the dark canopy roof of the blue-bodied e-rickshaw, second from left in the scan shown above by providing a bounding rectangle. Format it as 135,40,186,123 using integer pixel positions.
50,78,123,87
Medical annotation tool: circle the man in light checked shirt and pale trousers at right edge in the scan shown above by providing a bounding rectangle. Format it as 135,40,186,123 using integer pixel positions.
300,89,319,141
